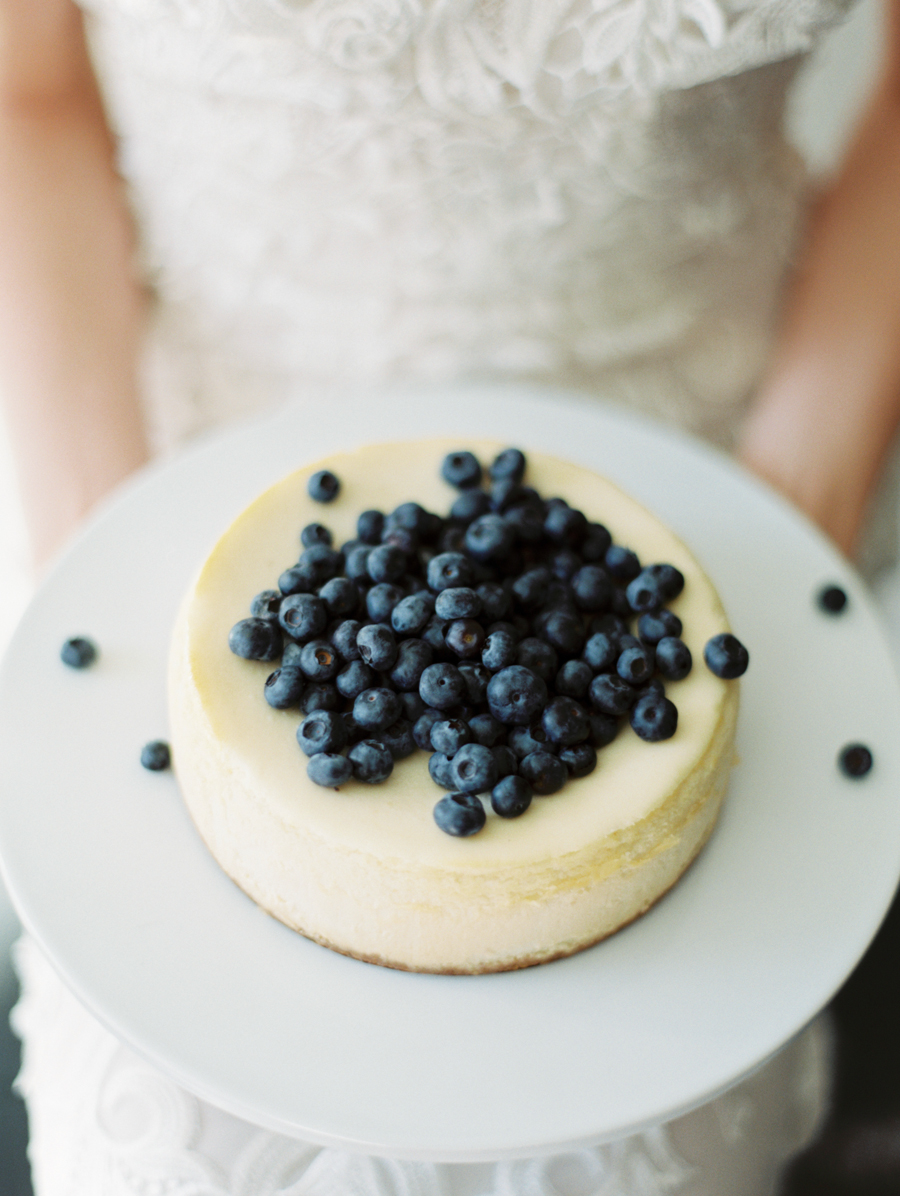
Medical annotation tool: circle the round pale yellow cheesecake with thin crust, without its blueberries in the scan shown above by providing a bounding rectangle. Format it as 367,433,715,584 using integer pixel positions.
170,440,739,972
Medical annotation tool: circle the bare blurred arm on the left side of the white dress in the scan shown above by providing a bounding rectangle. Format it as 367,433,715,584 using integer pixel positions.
0,0,147,574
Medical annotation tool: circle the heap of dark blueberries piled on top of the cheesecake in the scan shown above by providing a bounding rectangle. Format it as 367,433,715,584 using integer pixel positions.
228,449,747,835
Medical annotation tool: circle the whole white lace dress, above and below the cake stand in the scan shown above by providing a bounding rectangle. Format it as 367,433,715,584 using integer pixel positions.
10,0,860,1196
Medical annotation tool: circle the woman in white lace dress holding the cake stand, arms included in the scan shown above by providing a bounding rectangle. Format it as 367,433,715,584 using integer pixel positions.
0,0,900,1196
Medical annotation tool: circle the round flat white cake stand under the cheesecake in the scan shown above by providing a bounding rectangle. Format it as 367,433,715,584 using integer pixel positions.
0,386,900,1161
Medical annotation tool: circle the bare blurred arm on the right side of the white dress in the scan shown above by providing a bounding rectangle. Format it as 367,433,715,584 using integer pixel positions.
739,0,900,554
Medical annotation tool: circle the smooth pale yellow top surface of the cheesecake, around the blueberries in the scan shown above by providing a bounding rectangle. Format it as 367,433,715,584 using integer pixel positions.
182,439,734,871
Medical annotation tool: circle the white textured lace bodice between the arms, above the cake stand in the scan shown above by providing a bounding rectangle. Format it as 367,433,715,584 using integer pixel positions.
78,0,843,440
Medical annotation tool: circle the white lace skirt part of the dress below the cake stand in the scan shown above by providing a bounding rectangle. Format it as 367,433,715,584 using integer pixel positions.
13,939,825,1196
